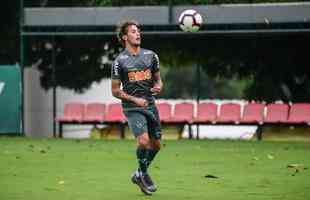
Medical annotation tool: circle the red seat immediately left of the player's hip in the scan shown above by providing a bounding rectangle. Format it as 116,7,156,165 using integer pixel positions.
105,103,125,122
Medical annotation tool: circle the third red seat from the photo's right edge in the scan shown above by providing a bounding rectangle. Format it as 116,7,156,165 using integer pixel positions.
241,103,265,124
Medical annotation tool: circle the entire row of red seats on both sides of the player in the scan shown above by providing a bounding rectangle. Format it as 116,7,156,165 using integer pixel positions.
57,102,310,125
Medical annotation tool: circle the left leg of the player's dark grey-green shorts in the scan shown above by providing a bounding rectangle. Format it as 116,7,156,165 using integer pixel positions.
124,111,148,138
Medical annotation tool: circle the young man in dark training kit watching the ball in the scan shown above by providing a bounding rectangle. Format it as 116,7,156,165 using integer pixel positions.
112,21,163,195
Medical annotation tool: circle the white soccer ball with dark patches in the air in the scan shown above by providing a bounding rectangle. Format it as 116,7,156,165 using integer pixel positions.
179,9,202,32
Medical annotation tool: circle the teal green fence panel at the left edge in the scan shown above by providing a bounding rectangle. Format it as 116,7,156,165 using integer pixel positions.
0,65,22,134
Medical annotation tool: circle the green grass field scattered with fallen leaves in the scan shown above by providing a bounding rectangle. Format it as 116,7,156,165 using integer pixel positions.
0,137,310,200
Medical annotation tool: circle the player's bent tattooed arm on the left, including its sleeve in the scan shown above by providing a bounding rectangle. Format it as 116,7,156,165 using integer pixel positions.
111,61,148,107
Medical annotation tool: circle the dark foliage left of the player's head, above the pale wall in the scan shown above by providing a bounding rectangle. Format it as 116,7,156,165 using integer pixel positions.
25,37,119,92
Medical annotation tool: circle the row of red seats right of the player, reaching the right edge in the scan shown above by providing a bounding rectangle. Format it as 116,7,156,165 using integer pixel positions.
158,103,310,124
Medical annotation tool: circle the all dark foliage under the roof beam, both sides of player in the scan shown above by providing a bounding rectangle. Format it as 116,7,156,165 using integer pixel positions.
26,35,310,102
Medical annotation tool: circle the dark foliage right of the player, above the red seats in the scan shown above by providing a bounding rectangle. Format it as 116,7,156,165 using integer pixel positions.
149,35,310,102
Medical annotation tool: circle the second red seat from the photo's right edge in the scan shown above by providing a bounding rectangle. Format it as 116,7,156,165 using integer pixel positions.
264,103,289,123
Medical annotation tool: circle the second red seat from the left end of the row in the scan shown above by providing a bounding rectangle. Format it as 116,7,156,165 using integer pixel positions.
84,103,105,122
